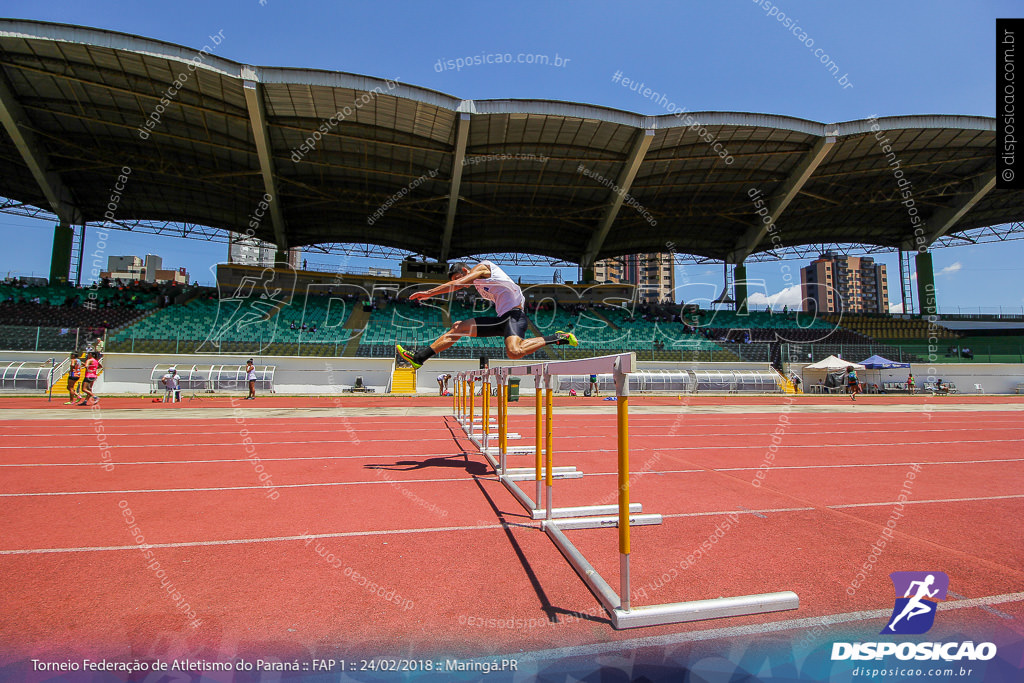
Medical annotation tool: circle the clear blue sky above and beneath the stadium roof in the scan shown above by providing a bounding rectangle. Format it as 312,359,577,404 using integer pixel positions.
0,0,1024,309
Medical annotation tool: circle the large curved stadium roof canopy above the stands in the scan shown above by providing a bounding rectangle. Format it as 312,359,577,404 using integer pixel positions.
0,20,1024,263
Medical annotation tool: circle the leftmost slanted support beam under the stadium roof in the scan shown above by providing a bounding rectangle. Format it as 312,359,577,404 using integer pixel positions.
0,67,83,225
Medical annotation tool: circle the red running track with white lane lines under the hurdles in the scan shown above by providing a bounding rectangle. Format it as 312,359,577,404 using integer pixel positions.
0,397,1024,658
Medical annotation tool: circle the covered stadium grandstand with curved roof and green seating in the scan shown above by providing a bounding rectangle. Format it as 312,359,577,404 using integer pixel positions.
0,19,1024,392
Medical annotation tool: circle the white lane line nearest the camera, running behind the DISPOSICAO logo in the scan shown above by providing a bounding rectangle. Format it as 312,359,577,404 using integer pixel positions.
507,593,1024,661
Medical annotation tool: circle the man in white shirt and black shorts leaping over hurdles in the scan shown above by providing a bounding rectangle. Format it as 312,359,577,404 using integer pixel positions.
395,261,580,368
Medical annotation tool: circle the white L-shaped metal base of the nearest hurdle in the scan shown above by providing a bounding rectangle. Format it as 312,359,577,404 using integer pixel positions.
544,521,800,629
